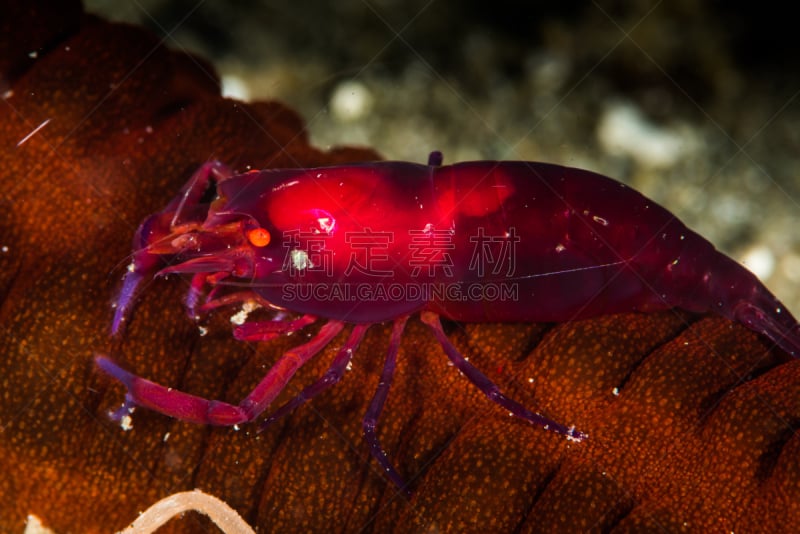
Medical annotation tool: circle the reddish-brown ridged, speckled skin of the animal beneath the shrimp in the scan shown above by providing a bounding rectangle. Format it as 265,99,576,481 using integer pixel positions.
0,3,800,533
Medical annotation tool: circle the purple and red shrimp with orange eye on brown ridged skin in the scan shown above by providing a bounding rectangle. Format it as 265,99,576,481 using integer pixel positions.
96,152,800,494
